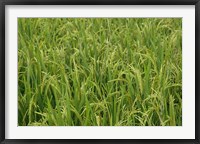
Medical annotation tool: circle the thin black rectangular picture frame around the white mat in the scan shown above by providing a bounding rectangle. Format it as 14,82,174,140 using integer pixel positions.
0,0,200,144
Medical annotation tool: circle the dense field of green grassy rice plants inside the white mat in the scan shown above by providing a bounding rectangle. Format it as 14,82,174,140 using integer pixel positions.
18,18,182,126
